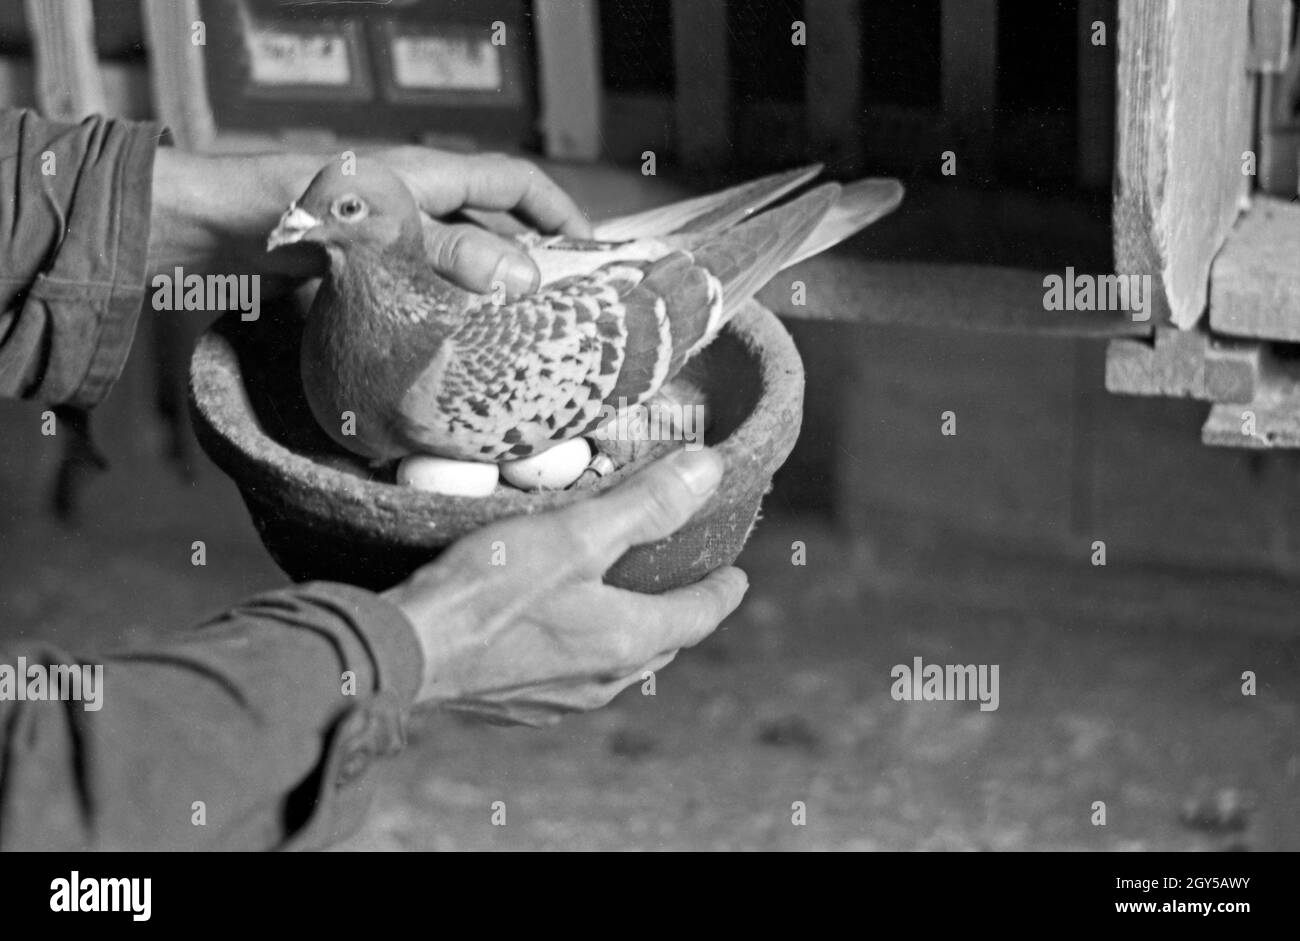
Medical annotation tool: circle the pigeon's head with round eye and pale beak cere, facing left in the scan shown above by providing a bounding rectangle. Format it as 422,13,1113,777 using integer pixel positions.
267,160,421,256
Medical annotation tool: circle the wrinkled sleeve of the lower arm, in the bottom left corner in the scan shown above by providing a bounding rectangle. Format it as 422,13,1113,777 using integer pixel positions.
0,582,423,850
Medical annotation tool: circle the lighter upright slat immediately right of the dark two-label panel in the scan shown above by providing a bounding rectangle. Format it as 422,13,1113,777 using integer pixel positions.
533,0,603,160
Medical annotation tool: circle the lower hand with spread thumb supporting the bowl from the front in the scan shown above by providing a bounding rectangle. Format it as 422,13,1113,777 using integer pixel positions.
385,448,749,725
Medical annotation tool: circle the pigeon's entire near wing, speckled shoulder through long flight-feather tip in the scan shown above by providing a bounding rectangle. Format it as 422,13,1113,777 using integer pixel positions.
399,183,840,460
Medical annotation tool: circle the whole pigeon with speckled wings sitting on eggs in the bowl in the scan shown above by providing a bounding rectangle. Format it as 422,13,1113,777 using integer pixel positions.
268,161,902,464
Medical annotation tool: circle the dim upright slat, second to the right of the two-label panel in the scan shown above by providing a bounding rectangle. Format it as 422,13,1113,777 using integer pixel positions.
672,0,731,166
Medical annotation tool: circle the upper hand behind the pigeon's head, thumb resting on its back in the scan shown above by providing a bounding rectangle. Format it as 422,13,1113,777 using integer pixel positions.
150,147,590,298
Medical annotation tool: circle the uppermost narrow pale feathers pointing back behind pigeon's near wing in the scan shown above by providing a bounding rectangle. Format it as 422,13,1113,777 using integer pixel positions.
595,164,822,242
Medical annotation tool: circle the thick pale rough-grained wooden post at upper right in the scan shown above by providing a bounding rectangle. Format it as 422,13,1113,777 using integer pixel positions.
1113,0,1252,328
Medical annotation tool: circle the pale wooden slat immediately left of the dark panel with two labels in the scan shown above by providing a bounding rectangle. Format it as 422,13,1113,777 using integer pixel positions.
142,0,217,151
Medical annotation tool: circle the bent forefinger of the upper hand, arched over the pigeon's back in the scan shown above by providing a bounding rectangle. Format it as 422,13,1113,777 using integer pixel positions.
452,155,592,238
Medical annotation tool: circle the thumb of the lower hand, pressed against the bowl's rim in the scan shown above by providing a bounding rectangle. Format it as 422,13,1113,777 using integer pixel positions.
555,448,724,577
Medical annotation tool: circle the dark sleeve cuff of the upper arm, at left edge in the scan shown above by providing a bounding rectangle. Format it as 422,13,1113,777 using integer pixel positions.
0,110,163,407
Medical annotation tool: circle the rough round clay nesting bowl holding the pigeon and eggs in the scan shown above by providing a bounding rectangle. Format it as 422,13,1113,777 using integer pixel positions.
190,293,803,593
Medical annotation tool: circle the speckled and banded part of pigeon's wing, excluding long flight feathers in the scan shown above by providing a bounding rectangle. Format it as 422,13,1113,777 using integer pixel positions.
400,252,722,460
